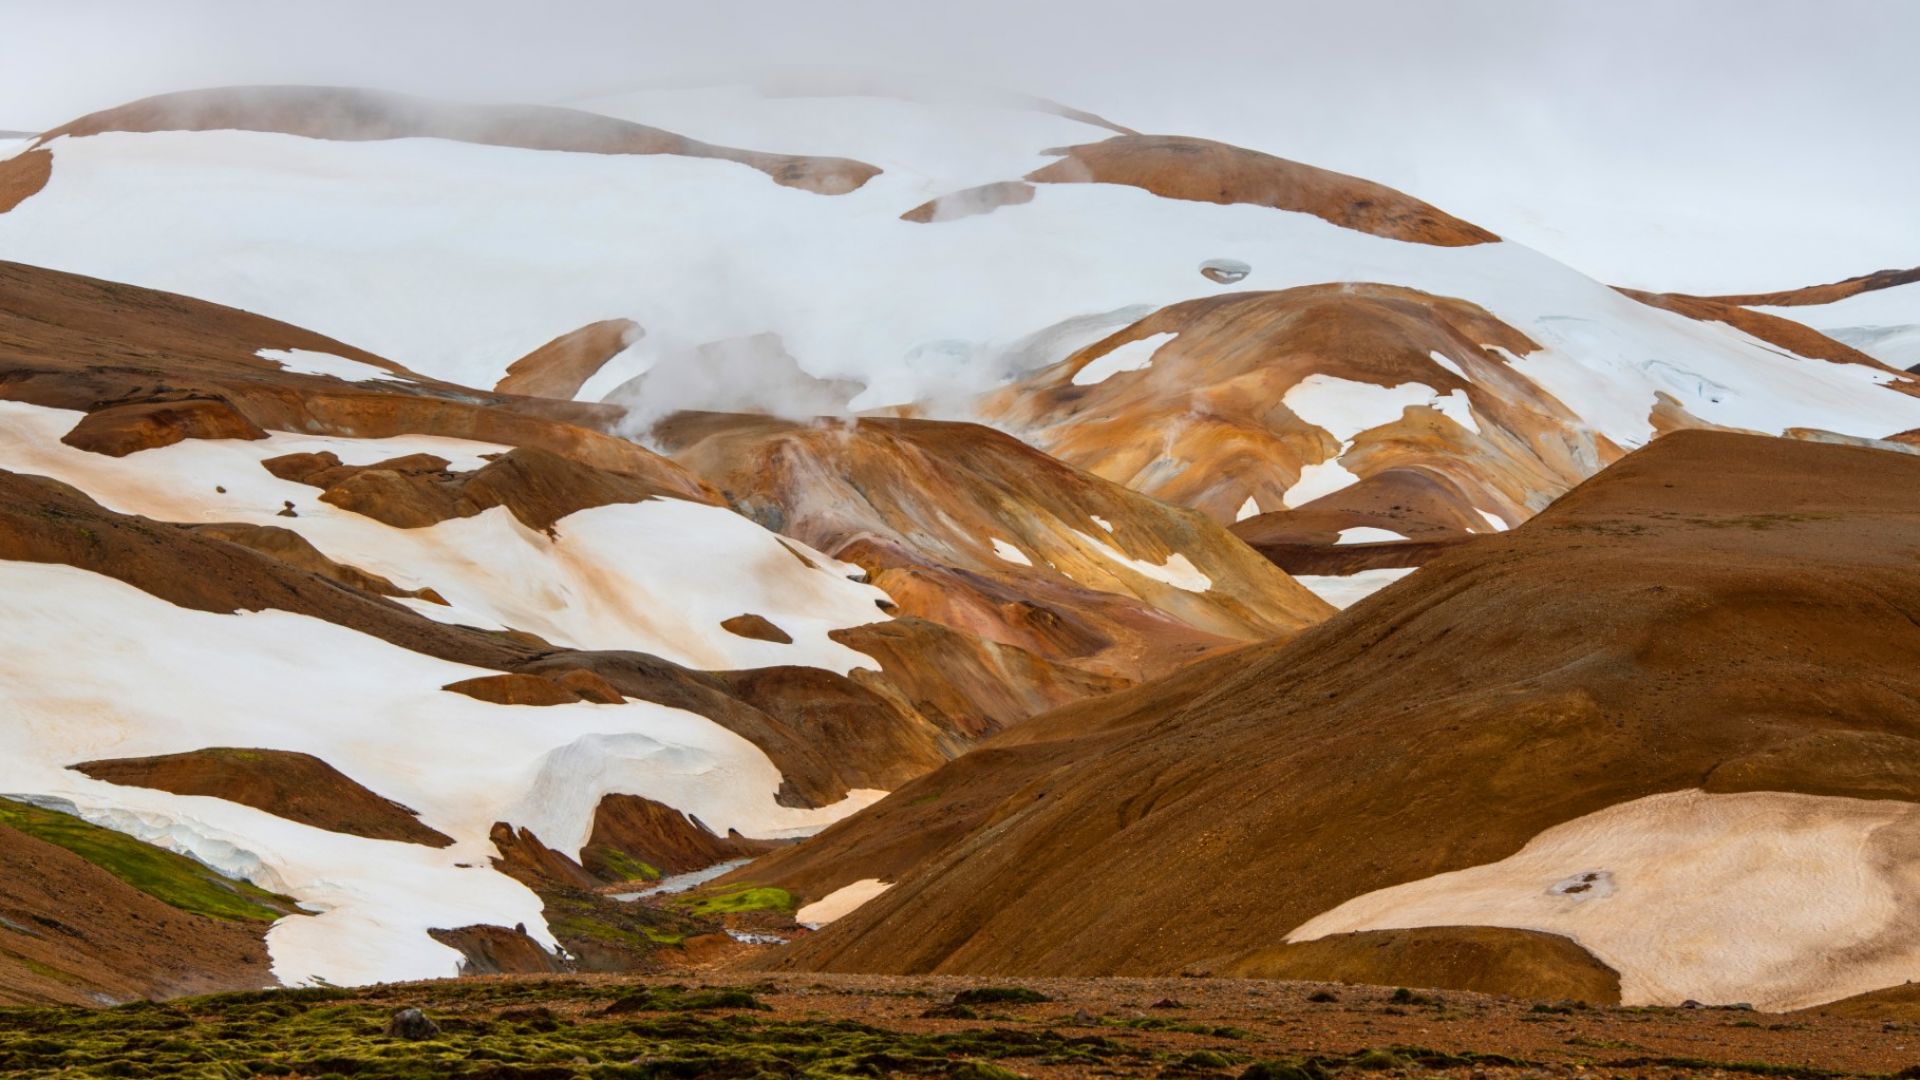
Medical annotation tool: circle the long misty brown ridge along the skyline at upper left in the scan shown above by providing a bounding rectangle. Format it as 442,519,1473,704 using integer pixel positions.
40,86,879,194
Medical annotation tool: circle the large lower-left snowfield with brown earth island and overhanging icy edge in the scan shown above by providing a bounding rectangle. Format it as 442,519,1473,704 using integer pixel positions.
0,561,881,984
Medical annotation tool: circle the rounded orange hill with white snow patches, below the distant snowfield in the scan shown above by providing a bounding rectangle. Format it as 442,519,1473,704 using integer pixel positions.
979,282,1620,534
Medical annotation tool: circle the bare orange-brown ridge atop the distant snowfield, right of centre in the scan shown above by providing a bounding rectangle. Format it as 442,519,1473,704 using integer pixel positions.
1027,135,1500,248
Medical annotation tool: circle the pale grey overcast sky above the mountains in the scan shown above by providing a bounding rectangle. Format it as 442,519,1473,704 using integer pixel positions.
0,0,1920,292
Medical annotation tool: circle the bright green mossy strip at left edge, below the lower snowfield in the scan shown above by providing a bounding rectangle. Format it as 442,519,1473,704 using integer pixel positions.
0,799,296,922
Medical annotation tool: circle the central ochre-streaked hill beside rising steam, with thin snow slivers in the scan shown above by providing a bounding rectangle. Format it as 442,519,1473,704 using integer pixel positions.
657,413,1327,680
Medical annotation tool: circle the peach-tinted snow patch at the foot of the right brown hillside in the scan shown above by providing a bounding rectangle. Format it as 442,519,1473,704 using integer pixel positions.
1288,790,1920,1009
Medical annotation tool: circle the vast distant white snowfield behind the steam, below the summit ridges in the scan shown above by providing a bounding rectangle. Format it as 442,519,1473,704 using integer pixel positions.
0,88,1920,457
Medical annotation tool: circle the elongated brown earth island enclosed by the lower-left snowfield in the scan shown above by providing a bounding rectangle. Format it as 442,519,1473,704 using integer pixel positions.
73,748,453,847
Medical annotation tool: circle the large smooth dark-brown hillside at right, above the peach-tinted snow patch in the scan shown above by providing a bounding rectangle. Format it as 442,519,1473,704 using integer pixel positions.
753,432,1920,1003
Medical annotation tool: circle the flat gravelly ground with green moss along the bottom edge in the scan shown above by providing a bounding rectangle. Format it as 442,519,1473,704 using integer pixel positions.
0,976,1920,1080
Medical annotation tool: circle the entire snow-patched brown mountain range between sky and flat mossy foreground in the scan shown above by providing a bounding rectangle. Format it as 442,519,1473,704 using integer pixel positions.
0,79,1920,1007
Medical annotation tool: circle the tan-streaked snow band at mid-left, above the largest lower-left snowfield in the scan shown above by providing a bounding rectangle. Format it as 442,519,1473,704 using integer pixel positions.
0,402,887,675
